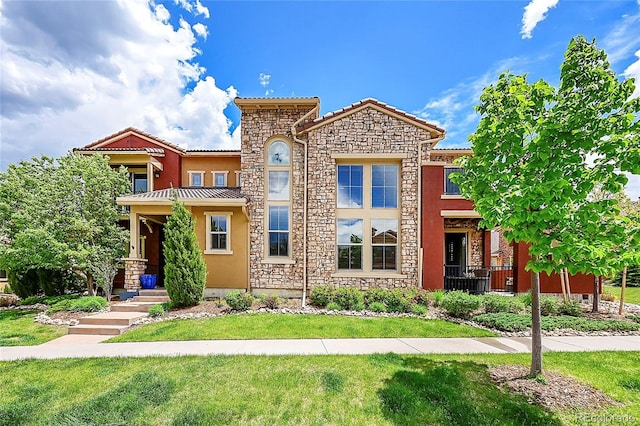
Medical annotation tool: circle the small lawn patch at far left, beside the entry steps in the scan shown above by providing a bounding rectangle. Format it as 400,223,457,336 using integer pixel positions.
0,309,67,346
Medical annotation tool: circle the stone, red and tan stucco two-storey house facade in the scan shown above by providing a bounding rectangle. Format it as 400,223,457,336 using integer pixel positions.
76,98,594,297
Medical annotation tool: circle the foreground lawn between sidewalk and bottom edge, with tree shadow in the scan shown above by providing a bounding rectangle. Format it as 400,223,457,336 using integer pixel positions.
0,352,640,426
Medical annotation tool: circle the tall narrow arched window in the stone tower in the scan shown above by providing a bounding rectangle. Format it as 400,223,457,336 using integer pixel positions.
265,140,291,258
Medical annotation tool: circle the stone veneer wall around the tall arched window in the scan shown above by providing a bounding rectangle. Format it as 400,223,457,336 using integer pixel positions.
241,109,315,291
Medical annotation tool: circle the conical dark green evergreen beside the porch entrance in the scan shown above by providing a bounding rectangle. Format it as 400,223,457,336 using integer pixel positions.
163,199,207,306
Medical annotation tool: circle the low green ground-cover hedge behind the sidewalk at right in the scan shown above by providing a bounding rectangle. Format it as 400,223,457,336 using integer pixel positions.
473,313,640,332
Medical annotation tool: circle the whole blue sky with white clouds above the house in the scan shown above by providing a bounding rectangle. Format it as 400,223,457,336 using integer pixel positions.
0,0,640,197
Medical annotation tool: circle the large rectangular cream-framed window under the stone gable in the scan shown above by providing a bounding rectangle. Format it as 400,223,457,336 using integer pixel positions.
336,163,400,272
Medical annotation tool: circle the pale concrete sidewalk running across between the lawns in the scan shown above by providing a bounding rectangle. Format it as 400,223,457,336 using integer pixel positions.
0,336,640,361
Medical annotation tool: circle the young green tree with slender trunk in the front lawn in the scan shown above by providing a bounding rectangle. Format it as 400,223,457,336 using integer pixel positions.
454,37,640,375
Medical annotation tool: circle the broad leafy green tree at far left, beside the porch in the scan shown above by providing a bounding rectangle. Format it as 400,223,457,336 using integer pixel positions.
0,153,130,294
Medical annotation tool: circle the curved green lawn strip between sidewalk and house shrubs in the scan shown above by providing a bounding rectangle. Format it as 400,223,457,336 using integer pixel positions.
109,314,495,342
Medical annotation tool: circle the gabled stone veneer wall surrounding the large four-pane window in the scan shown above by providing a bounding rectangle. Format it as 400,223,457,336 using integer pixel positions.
306,108,431,289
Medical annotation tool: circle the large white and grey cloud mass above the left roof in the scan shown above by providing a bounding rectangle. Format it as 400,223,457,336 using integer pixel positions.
0,0,239,169
